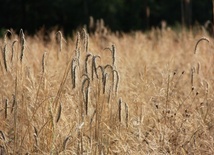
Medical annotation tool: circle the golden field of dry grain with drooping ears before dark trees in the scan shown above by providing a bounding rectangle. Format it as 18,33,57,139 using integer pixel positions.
0,29,214,155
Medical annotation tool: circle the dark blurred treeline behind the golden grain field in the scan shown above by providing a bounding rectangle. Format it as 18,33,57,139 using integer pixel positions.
0,0,212,33
